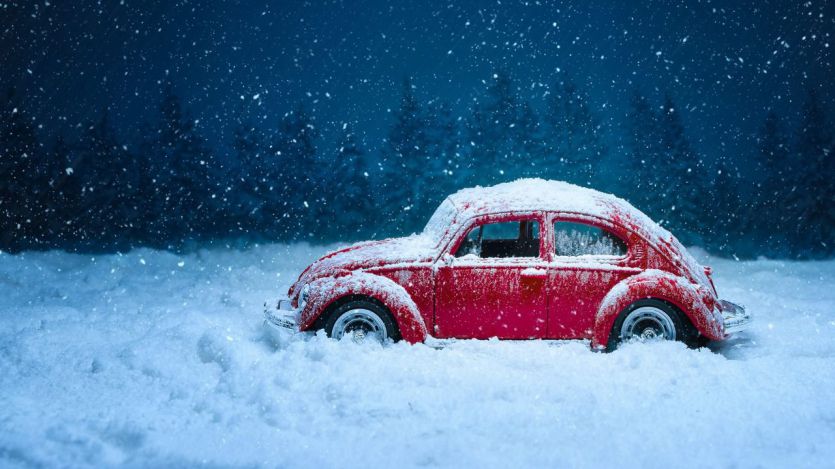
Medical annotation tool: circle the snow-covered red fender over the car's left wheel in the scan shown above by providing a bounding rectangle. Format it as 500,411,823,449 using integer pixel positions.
299,271,428,344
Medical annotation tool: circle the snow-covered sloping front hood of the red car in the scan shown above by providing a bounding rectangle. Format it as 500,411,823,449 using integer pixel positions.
289,234,438,298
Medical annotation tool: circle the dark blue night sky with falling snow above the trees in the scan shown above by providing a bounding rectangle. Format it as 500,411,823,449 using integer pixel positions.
0,0,835,157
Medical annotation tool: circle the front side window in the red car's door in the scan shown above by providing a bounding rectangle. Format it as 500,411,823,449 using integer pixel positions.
455,220,539,258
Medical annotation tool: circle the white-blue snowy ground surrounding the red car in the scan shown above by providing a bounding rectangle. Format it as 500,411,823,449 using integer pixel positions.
0,245,835,467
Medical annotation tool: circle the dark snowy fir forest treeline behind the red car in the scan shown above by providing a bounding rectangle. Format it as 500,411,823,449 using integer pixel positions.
0,74,835,258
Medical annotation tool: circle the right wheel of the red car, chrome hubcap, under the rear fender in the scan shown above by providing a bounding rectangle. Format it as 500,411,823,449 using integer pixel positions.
608,300,684,350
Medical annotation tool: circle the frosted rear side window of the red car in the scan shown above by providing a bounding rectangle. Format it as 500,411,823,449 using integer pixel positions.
554,221,626,257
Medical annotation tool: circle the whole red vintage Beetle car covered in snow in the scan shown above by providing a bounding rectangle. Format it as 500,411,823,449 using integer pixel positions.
266,179,750,350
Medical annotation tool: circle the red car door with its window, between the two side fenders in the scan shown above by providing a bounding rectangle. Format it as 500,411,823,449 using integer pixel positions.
435,214,547,339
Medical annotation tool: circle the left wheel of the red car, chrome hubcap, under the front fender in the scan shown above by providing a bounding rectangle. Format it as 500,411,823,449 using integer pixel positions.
325,300,400,343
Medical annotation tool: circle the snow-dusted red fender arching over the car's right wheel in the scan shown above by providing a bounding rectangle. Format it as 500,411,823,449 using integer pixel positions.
592,270,724,350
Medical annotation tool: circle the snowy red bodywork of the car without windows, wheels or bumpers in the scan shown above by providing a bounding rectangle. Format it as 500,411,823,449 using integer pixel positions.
289,180,725,348
